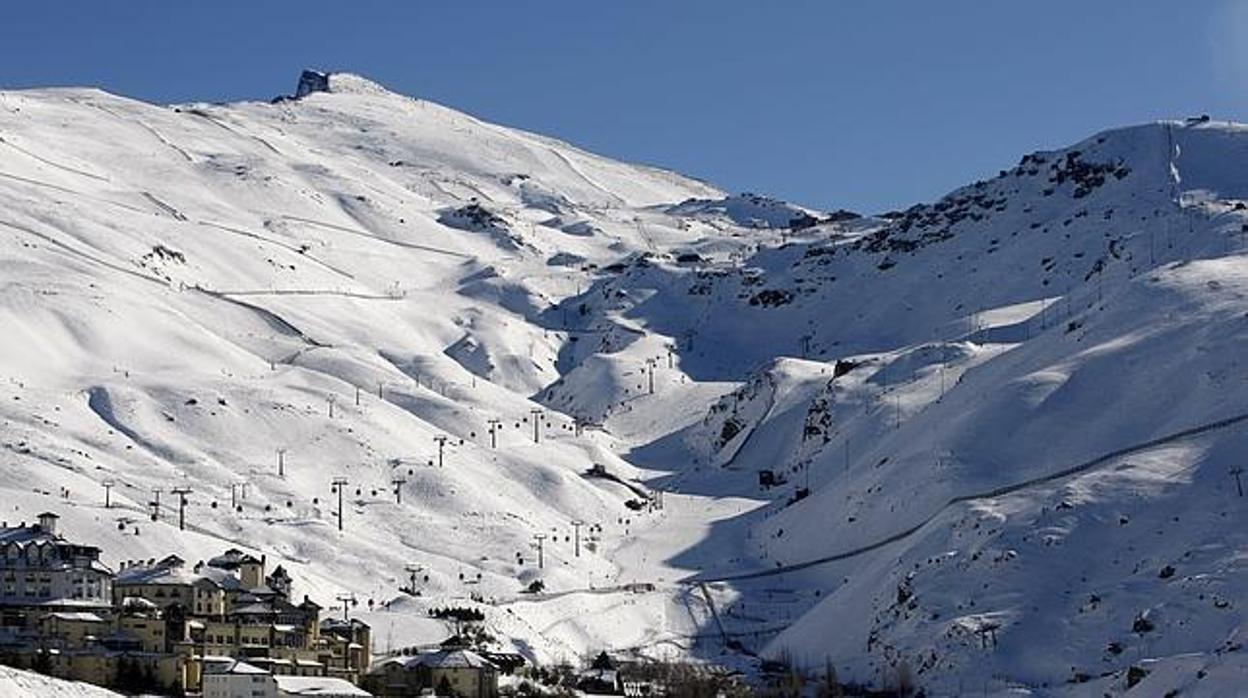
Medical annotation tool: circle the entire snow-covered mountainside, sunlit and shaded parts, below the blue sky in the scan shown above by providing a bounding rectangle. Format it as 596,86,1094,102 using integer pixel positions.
0,74,1248,696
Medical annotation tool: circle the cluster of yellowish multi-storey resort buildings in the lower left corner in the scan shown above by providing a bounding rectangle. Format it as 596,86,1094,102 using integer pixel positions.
0,513,372,697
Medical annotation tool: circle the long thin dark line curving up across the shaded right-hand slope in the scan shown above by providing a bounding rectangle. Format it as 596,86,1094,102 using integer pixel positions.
686,413,1248,584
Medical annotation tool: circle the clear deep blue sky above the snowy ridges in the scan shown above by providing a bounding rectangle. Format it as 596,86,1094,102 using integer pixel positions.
0,0,1248,211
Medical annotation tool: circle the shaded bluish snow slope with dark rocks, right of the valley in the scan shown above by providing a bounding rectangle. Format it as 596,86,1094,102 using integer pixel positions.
629,124,1248,694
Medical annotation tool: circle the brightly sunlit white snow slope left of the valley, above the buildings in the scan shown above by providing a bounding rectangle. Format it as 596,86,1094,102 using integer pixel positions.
0,75,758,661
